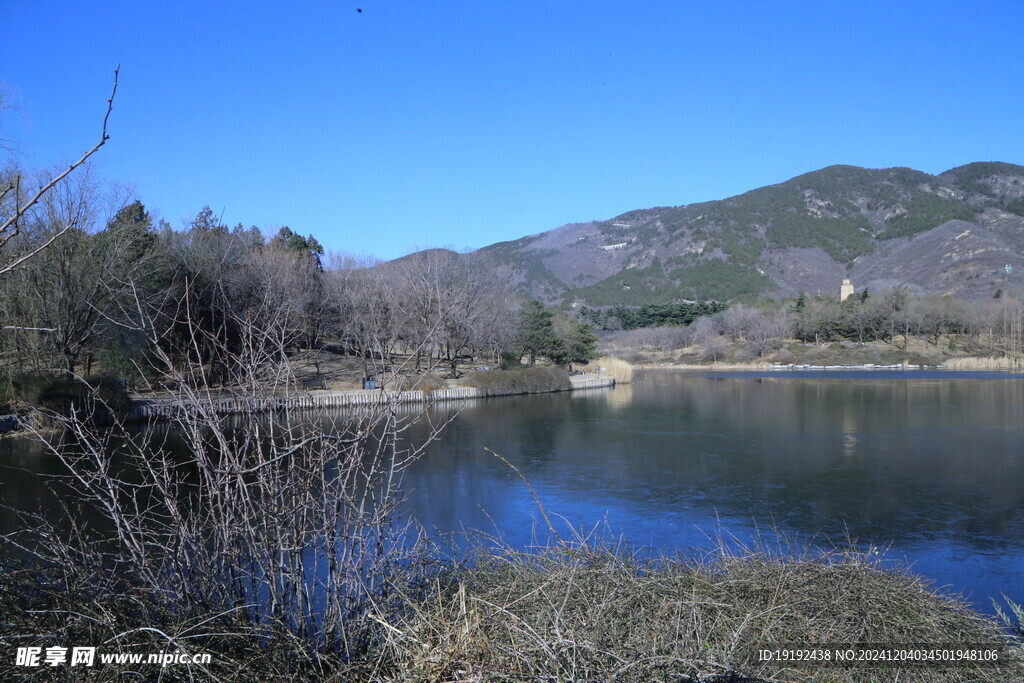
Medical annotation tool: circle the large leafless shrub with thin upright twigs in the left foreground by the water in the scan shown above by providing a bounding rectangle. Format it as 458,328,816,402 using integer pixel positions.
4,276,448,669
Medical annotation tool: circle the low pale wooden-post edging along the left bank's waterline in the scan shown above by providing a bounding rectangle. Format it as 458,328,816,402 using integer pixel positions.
131,377,615,420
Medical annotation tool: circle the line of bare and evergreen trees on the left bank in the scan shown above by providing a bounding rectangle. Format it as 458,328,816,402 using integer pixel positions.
0,166,595,411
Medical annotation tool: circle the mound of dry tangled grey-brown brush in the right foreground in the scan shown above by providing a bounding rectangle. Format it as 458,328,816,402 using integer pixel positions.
381,545,1024,681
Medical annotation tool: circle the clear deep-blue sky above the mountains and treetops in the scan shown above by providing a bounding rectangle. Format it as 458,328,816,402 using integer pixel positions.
0,0,1024,258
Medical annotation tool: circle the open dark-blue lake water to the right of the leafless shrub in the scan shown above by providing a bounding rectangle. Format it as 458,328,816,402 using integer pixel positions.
395,371,1024,612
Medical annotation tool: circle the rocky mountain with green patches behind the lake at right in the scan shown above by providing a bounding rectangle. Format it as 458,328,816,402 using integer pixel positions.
466,162,1024,306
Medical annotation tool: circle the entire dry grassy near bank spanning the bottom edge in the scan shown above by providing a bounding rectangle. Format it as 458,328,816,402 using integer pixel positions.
0,544,1024,682
